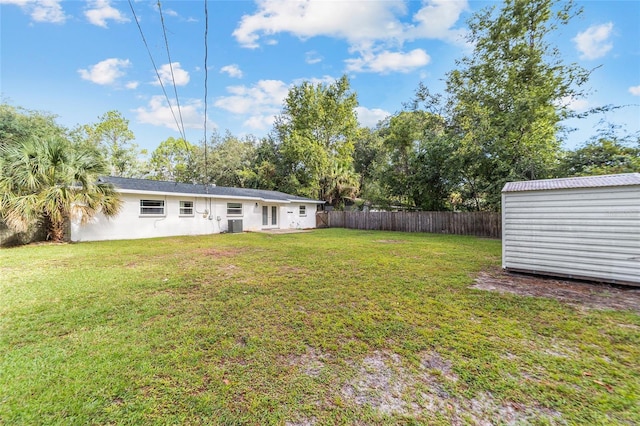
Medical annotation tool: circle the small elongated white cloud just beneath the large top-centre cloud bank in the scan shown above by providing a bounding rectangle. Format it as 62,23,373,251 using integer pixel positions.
345,49,431,74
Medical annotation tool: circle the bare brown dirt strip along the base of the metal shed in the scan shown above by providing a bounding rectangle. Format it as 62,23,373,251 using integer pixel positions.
471,270,640,313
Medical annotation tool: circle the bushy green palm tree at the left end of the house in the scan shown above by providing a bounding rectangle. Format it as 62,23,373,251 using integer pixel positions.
0,137,122,241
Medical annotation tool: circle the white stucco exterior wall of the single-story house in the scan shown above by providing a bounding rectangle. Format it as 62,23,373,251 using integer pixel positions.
71,193,316,241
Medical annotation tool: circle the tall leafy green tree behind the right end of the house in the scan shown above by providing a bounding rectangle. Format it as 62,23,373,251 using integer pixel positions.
274,76,358,202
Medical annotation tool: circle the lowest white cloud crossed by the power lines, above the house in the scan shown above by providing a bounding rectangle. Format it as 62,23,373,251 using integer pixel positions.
133,96,204,131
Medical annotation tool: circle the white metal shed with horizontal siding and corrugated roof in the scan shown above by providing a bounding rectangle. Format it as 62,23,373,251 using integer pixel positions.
502,173,640,286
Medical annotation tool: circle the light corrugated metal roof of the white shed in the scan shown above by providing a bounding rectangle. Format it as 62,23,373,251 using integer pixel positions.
502,173,640,192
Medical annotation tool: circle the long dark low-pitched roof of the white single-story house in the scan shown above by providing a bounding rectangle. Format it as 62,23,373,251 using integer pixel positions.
100,176,324,204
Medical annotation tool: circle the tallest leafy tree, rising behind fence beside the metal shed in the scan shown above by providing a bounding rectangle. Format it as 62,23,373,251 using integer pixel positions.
447,0,589,209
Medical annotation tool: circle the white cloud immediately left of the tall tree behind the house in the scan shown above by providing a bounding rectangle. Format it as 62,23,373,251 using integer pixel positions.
214,80,289,130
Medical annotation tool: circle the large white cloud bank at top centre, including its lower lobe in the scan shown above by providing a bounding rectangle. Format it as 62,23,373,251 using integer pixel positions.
233,0,469,73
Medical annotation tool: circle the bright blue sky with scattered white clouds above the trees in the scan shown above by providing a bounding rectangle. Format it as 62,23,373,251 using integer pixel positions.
0,0,640,151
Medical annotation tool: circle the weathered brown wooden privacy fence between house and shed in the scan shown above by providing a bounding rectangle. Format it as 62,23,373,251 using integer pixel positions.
316,211,502,238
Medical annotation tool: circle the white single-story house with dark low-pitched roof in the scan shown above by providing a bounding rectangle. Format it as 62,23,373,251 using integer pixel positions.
71,176,324,241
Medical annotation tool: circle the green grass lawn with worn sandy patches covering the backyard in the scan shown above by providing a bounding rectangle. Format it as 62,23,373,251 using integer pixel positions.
0,229,640,425
